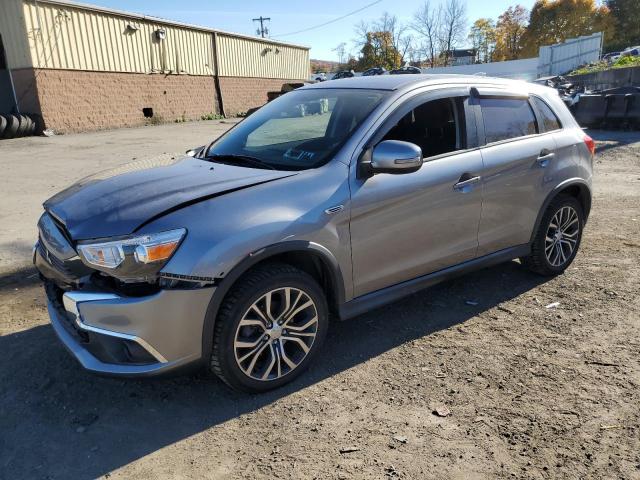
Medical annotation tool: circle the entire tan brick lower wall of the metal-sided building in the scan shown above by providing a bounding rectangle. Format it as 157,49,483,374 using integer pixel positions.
14,69,300,133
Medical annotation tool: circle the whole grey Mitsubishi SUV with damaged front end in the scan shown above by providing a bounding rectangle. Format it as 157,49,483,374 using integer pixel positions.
34,75,594,392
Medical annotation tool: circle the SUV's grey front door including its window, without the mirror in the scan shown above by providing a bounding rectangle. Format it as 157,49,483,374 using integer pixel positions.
351,92,482,296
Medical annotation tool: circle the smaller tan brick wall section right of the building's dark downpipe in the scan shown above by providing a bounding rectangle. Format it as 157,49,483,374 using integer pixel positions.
220,77,301,116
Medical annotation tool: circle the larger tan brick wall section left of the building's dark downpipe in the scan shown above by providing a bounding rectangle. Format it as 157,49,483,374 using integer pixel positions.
30,69,218,132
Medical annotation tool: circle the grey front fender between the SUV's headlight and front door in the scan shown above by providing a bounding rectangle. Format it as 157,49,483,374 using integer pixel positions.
151,162,351,284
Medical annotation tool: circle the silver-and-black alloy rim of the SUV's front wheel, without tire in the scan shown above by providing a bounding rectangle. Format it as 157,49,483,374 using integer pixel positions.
233,287,318,381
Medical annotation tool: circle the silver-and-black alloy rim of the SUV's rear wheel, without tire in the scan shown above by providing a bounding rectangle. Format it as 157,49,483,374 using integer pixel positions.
544,206,580,267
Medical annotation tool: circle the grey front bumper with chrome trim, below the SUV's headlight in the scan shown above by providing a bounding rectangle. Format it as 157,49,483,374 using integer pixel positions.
46,283,215,377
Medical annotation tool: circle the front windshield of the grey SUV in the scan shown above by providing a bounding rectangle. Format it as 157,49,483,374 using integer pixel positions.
206,88,385,170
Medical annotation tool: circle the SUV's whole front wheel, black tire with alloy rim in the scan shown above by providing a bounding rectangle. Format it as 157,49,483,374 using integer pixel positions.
210,263,329,393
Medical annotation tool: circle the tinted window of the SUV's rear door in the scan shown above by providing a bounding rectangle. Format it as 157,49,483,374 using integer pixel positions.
480,98,538,143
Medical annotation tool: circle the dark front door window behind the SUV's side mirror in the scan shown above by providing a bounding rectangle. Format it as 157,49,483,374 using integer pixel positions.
383,98,465,159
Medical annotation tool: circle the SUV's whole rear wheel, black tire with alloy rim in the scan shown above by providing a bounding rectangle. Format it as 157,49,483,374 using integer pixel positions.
520,195,584,276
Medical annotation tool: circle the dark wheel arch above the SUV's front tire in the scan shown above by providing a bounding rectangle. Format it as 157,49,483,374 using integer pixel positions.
202,240,345,362
